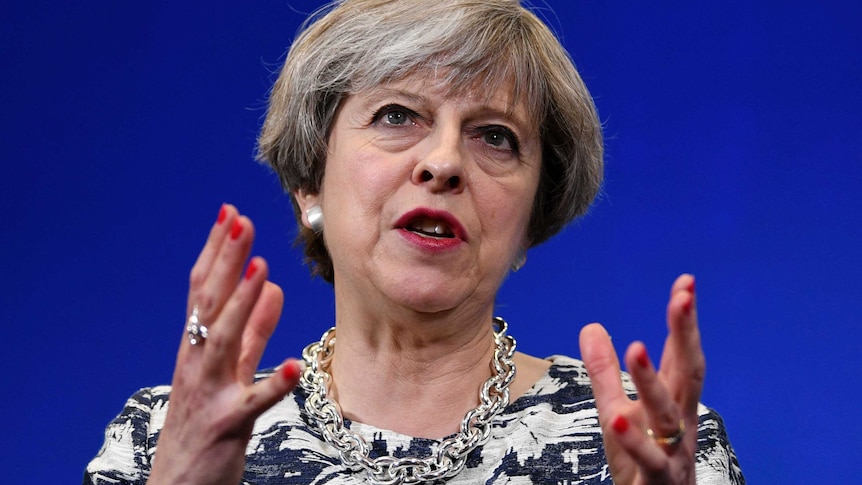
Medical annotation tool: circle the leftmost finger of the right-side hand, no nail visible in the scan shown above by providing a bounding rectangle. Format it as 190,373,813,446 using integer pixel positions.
579,323,629,410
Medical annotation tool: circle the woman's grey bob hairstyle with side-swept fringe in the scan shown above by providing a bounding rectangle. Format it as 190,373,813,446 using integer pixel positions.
258,0,603,282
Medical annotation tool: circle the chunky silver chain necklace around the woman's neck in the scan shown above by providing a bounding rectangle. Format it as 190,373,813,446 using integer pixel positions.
300,317,515,485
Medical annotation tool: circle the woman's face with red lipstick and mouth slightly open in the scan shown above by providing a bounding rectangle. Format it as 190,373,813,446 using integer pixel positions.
297,75,541,312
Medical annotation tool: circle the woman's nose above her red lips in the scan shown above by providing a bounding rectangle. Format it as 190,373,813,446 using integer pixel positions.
412,125,464,193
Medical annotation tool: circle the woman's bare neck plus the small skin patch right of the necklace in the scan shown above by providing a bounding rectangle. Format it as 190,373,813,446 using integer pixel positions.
318,276,549,439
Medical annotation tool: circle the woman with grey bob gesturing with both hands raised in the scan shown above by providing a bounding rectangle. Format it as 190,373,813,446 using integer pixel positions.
85,0,743,484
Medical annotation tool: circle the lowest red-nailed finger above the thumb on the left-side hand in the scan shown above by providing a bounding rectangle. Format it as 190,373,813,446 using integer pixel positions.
205,257,269,379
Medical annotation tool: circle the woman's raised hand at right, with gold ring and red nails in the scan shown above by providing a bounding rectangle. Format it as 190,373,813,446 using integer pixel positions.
580,275,706,484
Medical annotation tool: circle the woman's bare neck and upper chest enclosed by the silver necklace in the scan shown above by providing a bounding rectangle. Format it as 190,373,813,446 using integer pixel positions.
330,315,495,438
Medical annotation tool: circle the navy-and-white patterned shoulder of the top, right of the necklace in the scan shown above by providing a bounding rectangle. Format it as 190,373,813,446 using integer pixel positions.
492,355,744,484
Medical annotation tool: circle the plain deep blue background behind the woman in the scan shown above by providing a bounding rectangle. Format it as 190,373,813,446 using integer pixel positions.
0,0,862,483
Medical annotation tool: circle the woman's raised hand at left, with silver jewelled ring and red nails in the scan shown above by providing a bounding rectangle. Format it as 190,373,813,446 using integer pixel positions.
149,204,306,485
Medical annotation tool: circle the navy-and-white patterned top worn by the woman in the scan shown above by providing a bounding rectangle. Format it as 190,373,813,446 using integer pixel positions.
84,356,745,485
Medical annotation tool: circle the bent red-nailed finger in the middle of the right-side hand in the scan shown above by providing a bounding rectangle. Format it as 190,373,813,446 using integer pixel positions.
625,342,681,436
